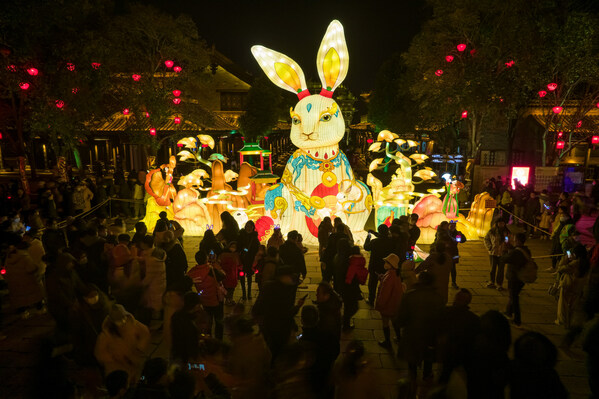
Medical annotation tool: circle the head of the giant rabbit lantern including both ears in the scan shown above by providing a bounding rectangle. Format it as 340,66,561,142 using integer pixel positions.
252,20,349,149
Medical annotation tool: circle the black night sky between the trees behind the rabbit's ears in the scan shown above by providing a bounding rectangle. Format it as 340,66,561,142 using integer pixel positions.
150,0,427,93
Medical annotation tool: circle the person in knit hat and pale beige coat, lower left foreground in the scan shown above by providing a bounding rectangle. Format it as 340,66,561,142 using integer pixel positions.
94,304,150,383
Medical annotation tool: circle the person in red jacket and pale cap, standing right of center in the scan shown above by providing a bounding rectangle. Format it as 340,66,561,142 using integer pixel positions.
374,254,404,349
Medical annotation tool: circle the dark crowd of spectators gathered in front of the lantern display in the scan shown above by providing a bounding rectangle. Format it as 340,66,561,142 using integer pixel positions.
0,178,599,399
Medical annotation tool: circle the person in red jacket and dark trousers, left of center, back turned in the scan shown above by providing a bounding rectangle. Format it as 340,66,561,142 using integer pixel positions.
187,251,225,340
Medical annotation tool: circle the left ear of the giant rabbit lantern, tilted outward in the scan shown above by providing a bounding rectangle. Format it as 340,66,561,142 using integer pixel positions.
252,46,310,100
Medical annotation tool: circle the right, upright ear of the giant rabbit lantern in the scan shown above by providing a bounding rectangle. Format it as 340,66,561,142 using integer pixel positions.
316,20,349,98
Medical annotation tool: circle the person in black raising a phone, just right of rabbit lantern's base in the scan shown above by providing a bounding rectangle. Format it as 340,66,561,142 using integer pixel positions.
364,224,394,306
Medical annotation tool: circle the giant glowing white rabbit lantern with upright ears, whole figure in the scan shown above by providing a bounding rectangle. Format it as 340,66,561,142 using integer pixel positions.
252,21,372,244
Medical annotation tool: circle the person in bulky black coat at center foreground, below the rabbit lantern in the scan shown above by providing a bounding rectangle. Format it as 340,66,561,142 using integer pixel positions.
252,265,304,362
